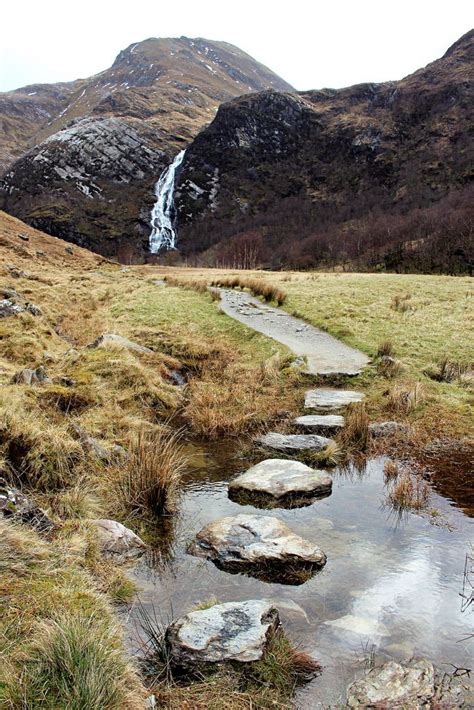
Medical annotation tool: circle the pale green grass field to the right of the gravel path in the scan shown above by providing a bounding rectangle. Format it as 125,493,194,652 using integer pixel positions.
285,273,474,437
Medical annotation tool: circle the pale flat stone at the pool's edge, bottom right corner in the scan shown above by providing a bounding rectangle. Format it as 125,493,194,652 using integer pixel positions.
347,658,435,710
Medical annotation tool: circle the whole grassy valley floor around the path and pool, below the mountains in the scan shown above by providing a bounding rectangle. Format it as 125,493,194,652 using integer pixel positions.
0,215,474,710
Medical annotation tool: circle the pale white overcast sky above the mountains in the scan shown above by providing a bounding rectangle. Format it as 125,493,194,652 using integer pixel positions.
0,0,474,91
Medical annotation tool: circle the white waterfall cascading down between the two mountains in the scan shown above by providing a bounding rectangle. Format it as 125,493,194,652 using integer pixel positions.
149,150,185,254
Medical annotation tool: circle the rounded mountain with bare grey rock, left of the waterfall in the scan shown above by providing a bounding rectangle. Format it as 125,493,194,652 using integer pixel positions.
0,37,292,259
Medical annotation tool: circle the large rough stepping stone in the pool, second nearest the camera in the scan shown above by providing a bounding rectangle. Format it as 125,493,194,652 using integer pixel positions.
187,515,326,584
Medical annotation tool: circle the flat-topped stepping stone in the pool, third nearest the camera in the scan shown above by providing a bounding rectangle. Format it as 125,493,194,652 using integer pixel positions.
229,459,332,508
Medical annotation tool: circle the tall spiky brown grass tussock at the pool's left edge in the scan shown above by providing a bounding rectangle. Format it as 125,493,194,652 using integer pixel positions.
115,428,188,515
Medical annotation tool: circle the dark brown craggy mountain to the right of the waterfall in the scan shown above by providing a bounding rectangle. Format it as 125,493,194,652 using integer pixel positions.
176,31,474,273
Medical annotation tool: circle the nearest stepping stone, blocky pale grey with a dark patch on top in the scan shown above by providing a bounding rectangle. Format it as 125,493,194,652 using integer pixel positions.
165,599,280,668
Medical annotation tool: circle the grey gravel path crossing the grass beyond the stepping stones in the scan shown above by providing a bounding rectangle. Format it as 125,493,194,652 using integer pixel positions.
220,289,369,375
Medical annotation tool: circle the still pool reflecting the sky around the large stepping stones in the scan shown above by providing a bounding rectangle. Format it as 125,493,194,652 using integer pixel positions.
128,446,473,709
